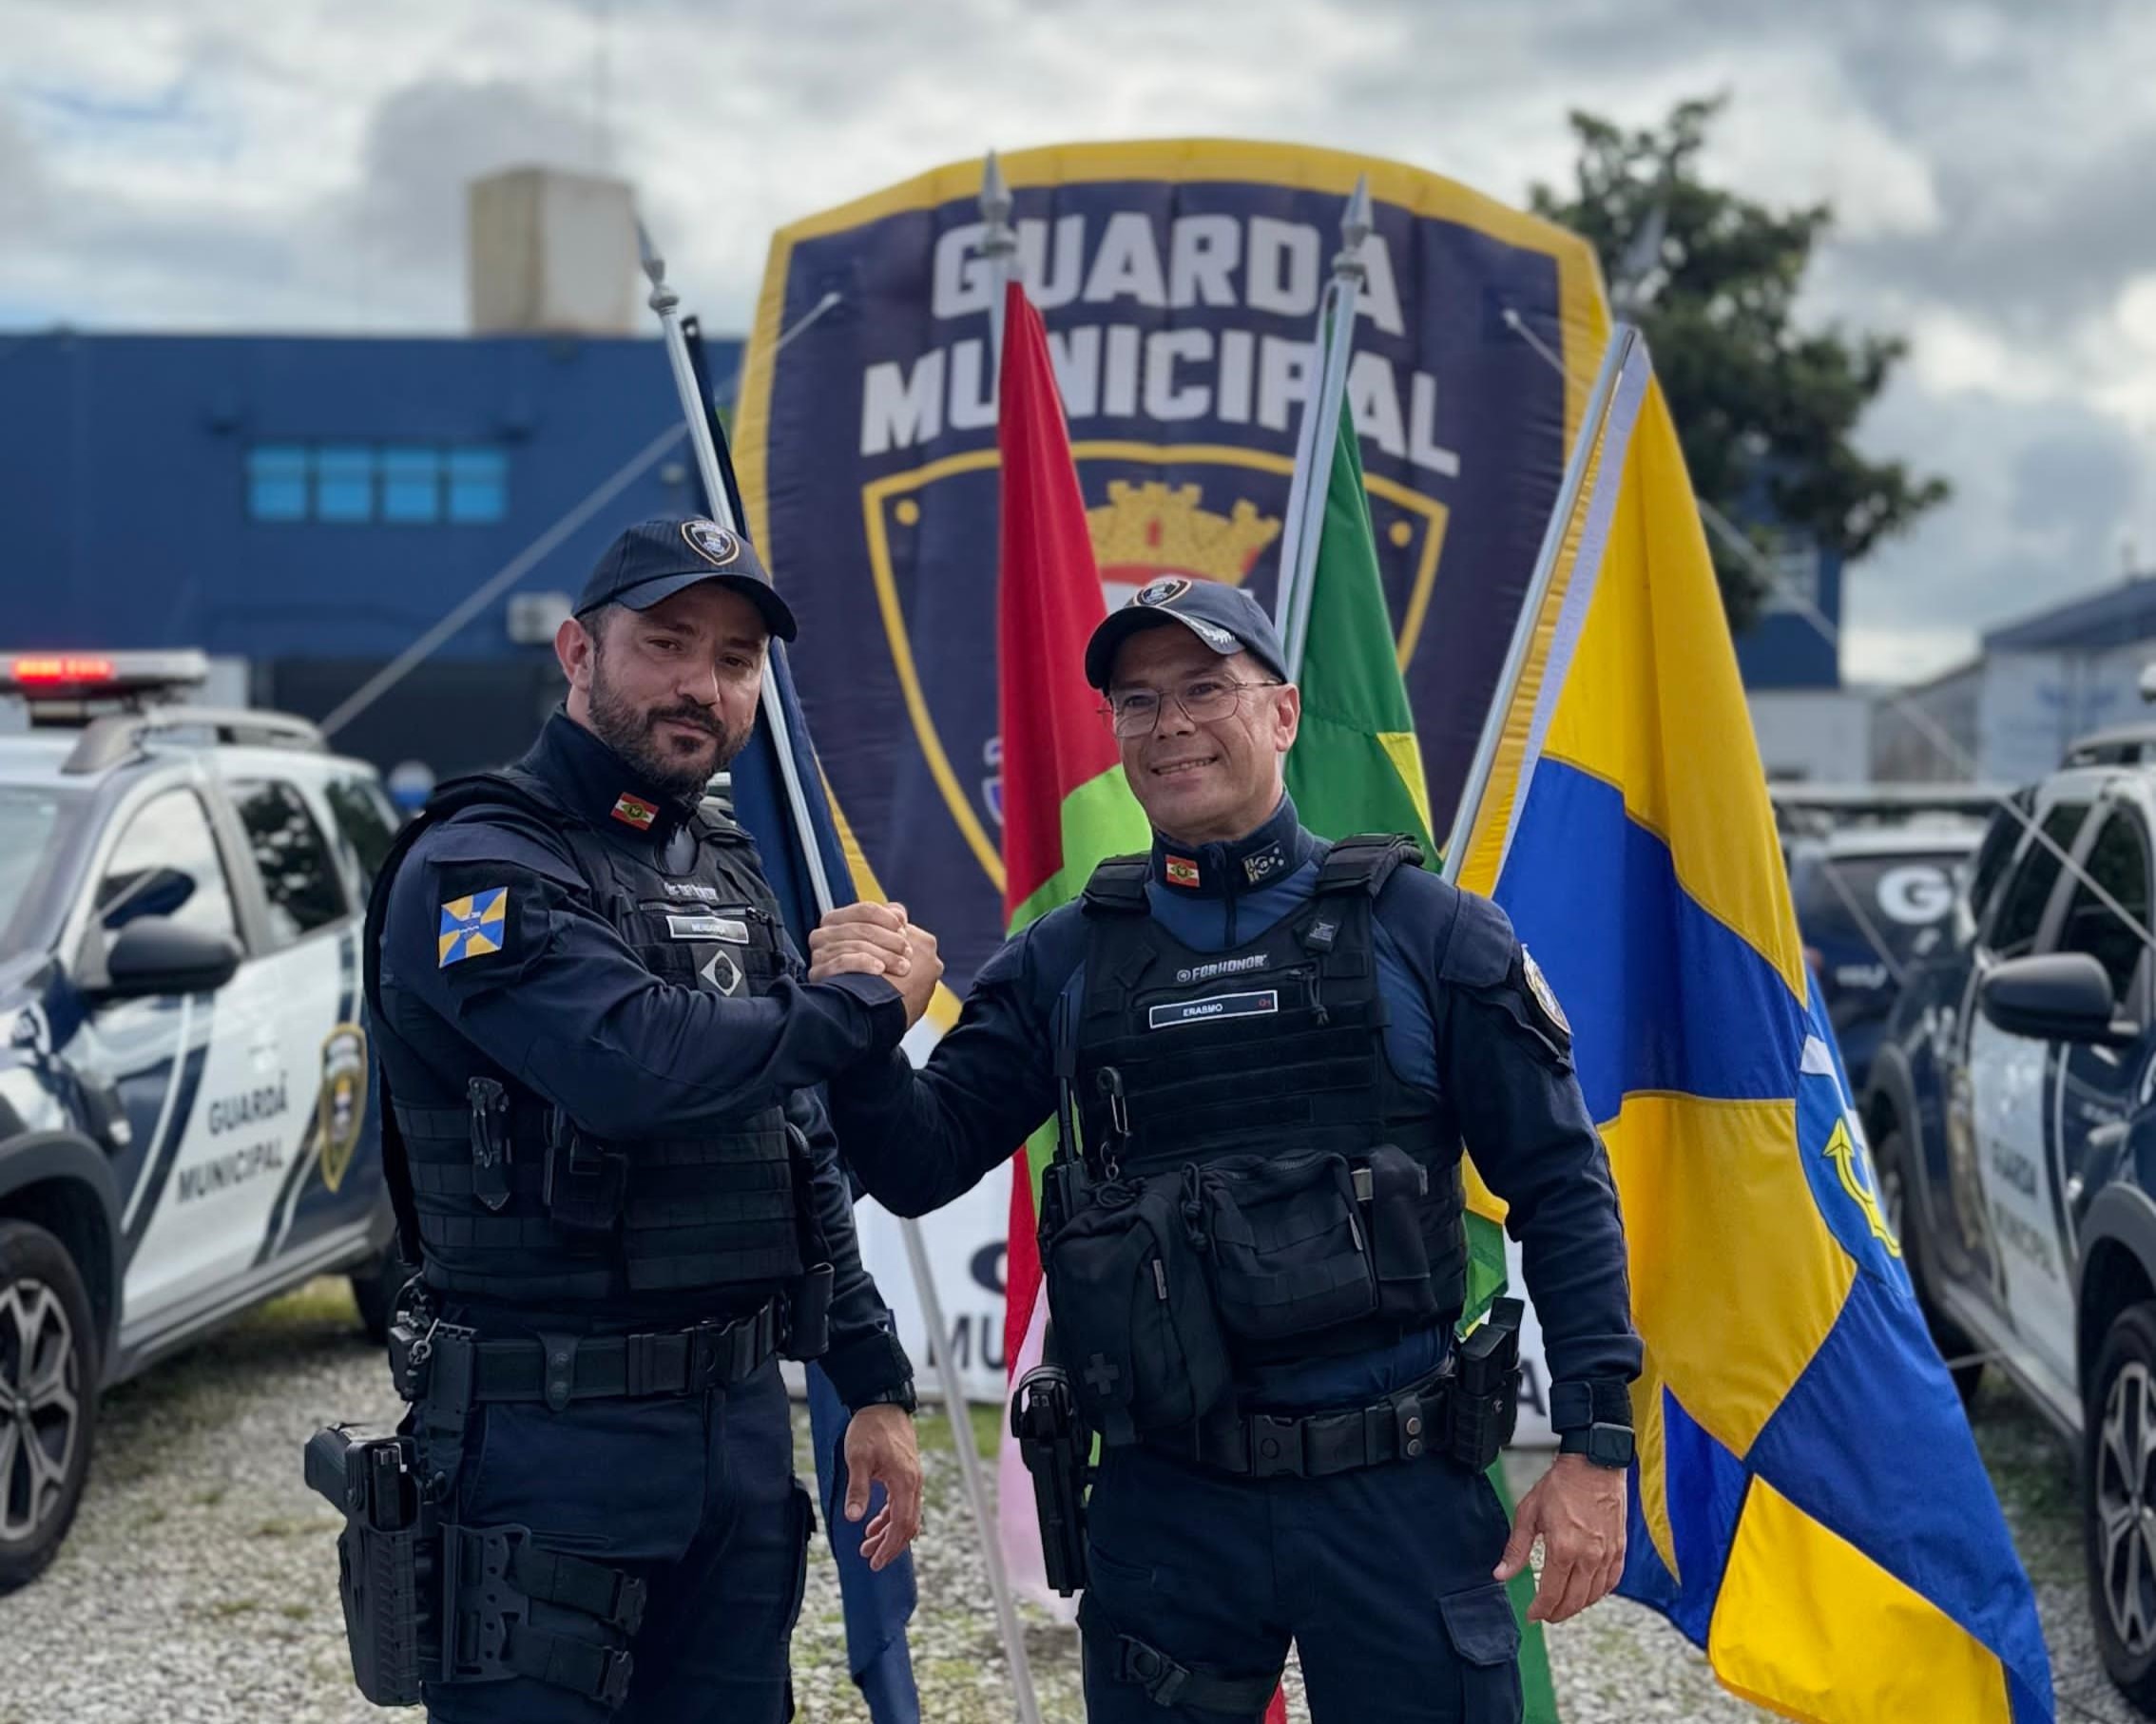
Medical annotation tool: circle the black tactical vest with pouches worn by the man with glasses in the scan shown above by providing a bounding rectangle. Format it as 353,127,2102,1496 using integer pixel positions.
1061,836,1466,1364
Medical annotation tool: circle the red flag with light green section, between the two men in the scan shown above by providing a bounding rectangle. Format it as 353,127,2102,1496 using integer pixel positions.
996,282,1151,1597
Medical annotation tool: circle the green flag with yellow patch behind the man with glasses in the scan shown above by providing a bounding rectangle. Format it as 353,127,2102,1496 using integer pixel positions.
1287,403,1556,1724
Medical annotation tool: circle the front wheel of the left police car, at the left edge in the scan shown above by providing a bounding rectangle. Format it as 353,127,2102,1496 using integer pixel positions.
0,1222,97,1593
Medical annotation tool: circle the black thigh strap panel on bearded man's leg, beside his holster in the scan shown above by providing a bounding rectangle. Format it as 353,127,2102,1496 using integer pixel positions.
442,1525,645,1707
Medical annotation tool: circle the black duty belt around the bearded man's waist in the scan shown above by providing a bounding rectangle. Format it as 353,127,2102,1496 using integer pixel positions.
391,1299,779,1411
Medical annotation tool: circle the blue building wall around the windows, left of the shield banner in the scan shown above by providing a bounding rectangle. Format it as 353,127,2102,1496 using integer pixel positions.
0,332,740,663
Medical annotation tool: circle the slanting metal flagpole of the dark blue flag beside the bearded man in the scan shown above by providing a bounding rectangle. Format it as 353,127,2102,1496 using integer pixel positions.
636,226,1041,1724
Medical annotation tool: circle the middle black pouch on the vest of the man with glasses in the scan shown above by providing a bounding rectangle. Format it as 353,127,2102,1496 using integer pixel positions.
1197,1151,1377,1343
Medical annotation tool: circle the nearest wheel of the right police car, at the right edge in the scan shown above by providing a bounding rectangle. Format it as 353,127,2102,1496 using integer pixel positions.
2081,1302,2156,1715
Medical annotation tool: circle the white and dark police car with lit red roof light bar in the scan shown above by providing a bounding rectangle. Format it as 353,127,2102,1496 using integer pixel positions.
0,653,396,1593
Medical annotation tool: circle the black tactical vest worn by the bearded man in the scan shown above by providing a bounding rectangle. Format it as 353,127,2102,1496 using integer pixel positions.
364,767,823,1304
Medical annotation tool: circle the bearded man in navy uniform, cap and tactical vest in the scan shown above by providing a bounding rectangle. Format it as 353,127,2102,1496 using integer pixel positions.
369,519,934,1724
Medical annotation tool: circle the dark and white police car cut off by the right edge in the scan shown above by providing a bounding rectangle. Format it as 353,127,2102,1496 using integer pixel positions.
1863,745,2156,1715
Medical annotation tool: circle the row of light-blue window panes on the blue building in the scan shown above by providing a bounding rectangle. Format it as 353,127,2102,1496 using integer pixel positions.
246,444,509,526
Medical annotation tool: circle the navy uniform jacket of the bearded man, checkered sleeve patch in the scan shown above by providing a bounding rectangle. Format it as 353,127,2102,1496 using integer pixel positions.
377,711,912,1408
